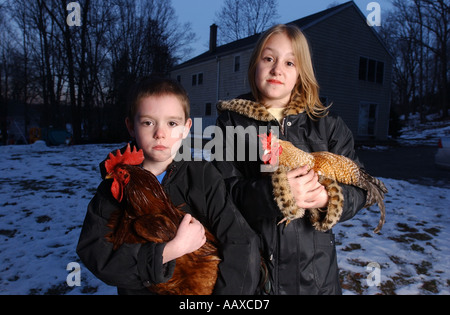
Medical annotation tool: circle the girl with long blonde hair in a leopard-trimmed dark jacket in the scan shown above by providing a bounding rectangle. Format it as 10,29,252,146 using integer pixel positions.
217,25,366,294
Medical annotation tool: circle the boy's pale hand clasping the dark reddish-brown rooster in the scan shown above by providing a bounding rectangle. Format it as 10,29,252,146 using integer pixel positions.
163,214,206,264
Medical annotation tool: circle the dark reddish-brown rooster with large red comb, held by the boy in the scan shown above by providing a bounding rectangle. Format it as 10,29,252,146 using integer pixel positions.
105,144,220,295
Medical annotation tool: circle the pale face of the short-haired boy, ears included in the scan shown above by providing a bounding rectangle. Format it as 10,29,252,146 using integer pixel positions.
126,95,192,166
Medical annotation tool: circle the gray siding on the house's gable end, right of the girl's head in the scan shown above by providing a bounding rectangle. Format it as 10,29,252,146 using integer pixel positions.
305,6,392,140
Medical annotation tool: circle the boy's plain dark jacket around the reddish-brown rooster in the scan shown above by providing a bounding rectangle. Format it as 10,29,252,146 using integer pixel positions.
77,152,261,294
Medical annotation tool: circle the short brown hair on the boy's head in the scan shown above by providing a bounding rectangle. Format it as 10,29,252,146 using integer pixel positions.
127,78,191,123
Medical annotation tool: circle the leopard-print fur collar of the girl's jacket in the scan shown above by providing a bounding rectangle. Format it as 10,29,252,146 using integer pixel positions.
217,94,305,122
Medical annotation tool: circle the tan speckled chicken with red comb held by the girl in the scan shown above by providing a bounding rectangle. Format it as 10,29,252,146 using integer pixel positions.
259,133,388,233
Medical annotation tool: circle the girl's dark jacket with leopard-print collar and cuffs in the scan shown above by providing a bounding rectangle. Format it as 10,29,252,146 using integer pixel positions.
216,95,366,294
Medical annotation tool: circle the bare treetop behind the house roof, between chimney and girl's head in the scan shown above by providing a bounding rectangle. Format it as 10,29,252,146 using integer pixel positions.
215,0,279,44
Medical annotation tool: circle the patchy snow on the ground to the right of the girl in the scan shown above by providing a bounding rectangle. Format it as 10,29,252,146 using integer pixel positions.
334,179,450,294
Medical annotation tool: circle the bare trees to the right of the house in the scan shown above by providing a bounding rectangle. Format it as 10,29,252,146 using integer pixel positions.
381,0,450,119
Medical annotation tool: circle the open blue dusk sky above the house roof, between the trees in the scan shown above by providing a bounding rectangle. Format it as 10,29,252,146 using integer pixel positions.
172,0,392,57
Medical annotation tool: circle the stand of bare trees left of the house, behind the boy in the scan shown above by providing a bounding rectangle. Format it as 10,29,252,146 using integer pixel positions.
0,0,194,143
